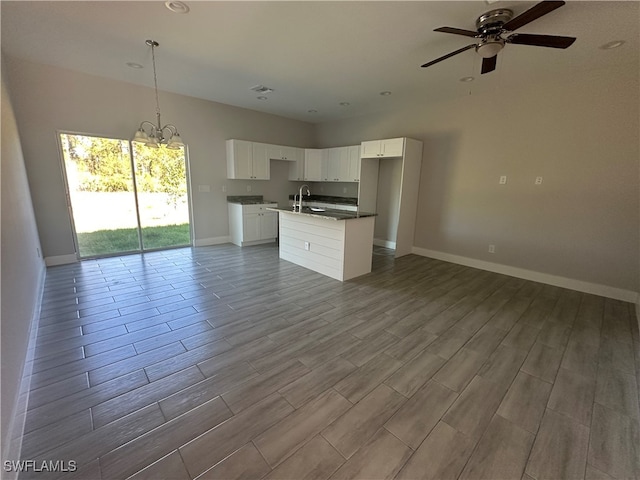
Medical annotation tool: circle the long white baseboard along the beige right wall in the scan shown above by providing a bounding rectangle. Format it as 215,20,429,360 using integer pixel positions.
411,247,639,304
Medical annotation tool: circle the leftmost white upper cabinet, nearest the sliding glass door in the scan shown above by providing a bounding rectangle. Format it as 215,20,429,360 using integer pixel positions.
227,140,270,180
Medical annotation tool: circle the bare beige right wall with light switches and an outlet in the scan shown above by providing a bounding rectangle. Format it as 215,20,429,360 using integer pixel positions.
316,65,640,293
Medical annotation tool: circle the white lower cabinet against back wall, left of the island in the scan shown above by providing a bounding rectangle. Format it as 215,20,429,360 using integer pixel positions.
229,203,278,247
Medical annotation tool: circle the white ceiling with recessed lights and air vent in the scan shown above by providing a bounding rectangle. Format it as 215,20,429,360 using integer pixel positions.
1,0,640,122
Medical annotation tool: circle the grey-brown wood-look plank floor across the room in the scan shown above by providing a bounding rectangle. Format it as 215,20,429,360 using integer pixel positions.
20,245,640,479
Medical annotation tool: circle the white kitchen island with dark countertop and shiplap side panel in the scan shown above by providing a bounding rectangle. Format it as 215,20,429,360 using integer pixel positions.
269,207,375,281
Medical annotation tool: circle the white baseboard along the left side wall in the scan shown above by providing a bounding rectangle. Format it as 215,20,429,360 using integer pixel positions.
2,262,47,480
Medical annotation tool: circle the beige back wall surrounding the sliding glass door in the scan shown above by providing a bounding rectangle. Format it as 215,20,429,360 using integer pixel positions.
5,56,314,259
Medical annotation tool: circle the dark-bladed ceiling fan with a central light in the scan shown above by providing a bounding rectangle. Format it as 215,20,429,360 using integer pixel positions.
422,0,576,74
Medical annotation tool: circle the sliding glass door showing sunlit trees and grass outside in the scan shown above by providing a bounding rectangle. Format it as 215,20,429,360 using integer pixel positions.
59,133,192,258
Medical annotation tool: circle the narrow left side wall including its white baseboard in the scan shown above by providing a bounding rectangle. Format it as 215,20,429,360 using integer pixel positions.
0,55,45,472
